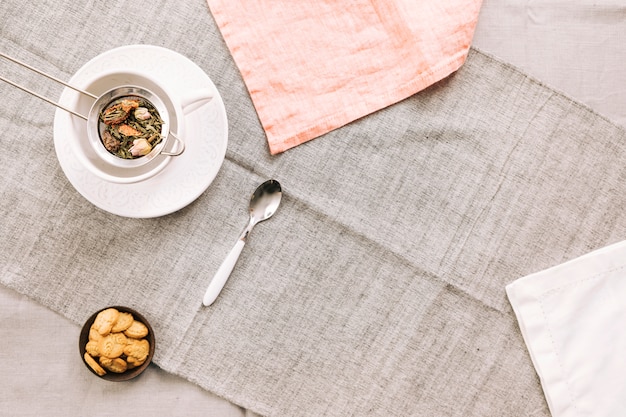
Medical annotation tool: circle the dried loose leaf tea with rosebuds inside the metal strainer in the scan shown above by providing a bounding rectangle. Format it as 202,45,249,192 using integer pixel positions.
100,96,163,159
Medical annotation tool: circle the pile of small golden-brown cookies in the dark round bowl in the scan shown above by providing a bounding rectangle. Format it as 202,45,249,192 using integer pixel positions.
84,308,150,376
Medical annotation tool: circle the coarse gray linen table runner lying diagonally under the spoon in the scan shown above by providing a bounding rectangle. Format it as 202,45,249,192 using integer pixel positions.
0,0,626,416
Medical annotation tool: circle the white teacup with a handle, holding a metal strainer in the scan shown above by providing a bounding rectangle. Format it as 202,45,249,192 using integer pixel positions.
65,70,213,184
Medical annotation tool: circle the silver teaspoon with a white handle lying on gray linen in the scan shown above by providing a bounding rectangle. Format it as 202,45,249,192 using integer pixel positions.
202,180,282,306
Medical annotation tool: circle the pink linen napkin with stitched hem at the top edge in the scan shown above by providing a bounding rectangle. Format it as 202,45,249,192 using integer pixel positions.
207,0,482,154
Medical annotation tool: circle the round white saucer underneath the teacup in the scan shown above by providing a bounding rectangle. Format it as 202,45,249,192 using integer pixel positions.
54,45,228,218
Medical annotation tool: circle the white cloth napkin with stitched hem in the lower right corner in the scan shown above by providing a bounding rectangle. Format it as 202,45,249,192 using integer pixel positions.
506,241,626,417
